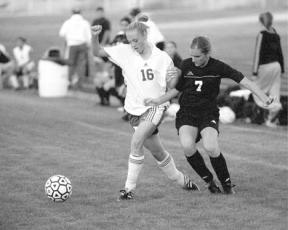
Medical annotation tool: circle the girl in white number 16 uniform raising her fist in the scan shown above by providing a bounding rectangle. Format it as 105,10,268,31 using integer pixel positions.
92,22,199,200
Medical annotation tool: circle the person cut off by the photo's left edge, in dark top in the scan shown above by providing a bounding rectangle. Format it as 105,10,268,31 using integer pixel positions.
0,44,19,89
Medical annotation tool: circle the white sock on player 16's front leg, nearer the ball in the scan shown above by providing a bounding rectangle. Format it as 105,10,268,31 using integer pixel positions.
125,154,144,192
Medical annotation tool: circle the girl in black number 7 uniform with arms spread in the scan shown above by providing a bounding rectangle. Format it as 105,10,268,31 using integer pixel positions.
145,36,274,194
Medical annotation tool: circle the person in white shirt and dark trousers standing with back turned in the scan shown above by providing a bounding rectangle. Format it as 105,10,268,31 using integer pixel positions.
59,8,91,88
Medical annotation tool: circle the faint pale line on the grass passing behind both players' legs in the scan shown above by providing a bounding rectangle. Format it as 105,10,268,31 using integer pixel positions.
74,121,288,171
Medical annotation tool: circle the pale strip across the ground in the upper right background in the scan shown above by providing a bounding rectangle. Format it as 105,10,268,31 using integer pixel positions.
157,12,288,29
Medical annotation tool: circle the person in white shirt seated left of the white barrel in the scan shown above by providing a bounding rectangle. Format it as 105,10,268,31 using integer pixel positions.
13,37,36,89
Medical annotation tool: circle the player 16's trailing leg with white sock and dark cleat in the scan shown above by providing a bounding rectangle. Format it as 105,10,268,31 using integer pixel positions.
144,133,199,190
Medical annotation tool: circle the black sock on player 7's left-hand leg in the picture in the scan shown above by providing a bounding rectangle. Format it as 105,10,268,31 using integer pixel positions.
186,151,213,183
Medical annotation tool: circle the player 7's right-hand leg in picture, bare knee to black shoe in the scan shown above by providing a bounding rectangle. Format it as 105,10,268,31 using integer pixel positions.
201,127,234,194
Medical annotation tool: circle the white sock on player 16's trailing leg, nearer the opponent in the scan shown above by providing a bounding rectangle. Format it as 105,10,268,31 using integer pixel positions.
157,153,184,187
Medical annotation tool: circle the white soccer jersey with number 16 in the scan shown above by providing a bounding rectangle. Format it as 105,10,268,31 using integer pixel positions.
104,44,173,116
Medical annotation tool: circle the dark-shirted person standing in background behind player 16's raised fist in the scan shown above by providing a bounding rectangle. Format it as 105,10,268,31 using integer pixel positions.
92,7,111,46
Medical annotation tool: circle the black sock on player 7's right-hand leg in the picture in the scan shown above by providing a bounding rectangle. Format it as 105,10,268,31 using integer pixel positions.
210,153,231,184
